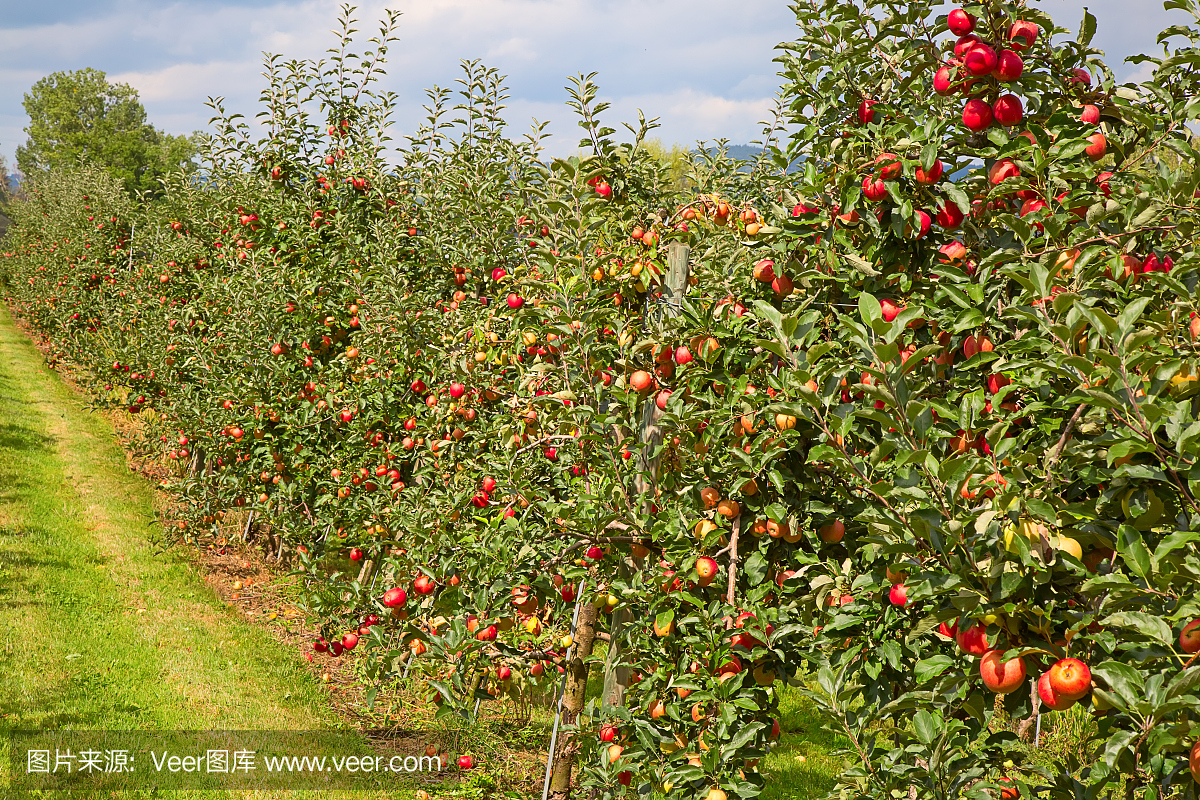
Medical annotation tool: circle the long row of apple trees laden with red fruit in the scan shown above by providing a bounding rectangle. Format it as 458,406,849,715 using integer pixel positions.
7,0,1200,798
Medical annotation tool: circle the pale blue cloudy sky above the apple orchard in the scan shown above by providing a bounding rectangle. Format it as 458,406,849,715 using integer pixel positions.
0,0,1189,166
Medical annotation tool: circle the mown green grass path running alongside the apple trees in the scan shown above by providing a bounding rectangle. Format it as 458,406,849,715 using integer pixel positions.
0,307,405,796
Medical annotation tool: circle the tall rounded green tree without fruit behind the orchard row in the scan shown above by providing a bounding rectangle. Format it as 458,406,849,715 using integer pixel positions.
17,68,196,194
